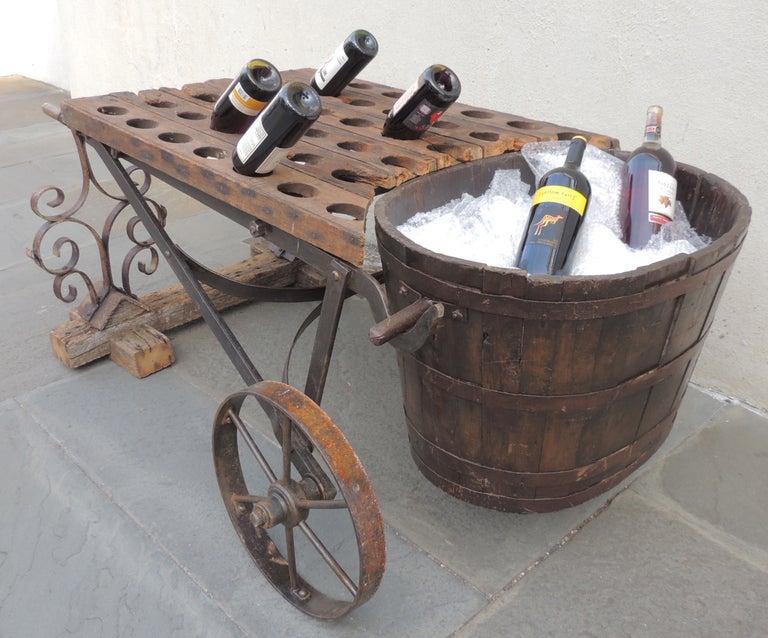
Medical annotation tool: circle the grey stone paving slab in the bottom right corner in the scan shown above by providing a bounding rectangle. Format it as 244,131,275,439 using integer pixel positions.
455,490,768,638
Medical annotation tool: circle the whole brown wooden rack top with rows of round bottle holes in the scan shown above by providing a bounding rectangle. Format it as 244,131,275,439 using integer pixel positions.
54,69,618,265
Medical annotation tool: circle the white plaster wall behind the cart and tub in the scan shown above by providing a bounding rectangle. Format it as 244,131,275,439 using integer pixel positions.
7,0,768,409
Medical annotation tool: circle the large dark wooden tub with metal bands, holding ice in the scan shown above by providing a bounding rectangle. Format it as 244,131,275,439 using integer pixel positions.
375,153,751,512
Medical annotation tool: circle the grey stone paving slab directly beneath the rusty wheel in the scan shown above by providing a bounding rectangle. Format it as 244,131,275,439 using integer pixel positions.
3,361,486,636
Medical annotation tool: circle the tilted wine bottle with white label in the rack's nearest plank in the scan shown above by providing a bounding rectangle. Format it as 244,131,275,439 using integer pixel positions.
232,82,322,175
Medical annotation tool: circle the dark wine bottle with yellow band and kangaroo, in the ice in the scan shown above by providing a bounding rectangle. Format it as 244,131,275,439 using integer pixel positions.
517,136,592,275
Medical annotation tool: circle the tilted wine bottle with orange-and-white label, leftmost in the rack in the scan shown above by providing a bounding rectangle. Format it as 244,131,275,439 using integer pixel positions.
211,59,283,135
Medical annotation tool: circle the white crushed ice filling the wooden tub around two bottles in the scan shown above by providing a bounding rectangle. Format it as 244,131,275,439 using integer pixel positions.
398,141,709,275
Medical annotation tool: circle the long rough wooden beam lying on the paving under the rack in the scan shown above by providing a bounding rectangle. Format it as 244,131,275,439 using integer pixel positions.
50,252,300,368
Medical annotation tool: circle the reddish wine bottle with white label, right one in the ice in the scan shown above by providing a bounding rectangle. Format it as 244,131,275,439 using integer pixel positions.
620,106,677,248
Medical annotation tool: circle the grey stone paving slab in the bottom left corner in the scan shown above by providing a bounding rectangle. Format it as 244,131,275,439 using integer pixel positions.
0,400,245,638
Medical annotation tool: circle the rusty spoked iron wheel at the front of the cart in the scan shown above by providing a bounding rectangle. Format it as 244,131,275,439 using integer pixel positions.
213,381,385,619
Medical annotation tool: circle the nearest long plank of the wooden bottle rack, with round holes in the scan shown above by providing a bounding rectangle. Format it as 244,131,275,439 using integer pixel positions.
56,95,371,265
